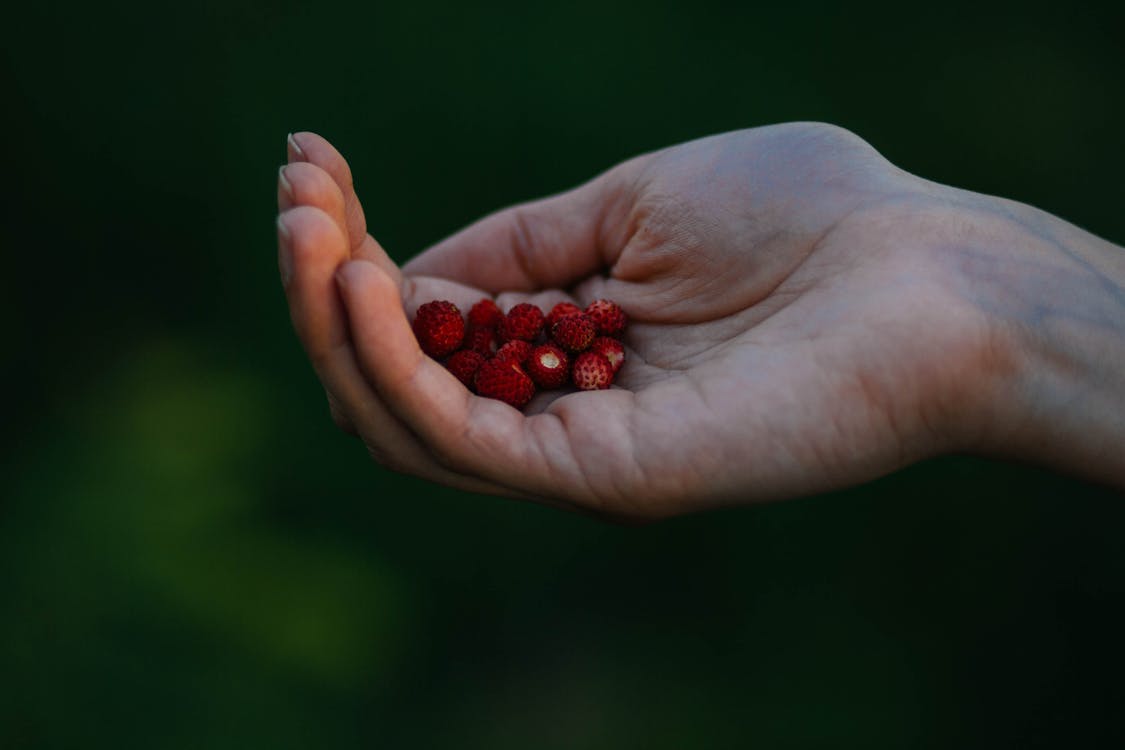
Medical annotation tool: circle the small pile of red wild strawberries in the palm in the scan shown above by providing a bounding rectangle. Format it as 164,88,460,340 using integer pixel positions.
413,299,626,408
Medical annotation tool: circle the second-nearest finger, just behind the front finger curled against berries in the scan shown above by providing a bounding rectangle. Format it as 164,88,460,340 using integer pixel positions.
278,206,512,495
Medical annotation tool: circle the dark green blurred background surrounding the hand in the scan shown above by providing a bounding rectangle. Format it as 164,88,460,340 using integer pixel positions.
0,0,1125,750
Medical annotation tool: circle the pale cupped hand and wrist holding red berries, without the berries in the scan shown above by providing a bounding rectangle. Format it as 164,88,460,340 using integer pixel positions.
278,124,1125,521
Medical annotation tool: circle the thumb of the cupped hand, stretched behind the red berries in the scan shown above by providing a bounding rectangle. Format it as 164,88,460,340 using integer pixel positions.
403,157,645,293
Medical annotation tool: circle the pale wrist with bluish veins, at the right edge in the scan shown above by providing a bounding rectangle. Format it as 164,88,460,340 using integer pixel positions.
961,198,1125,487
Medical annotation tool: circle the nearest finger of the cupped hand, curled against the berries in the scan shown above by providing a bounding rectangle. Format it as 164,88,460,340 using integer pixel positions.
336,261,565,499
